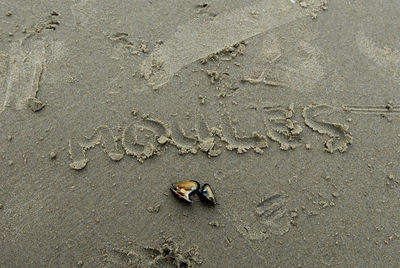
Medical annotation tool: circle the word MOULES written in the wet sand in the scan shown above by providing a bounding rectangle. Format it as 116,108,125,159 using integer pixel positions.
69,104,353,170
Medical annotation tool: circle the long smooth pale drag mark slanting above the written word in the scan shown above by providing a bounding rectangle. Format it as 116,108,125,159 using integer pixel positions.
141,0,306,89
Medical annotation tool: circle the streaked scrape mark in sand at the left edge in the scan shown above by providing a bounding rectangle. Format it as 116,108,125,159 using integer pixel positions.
0,40,46,113
